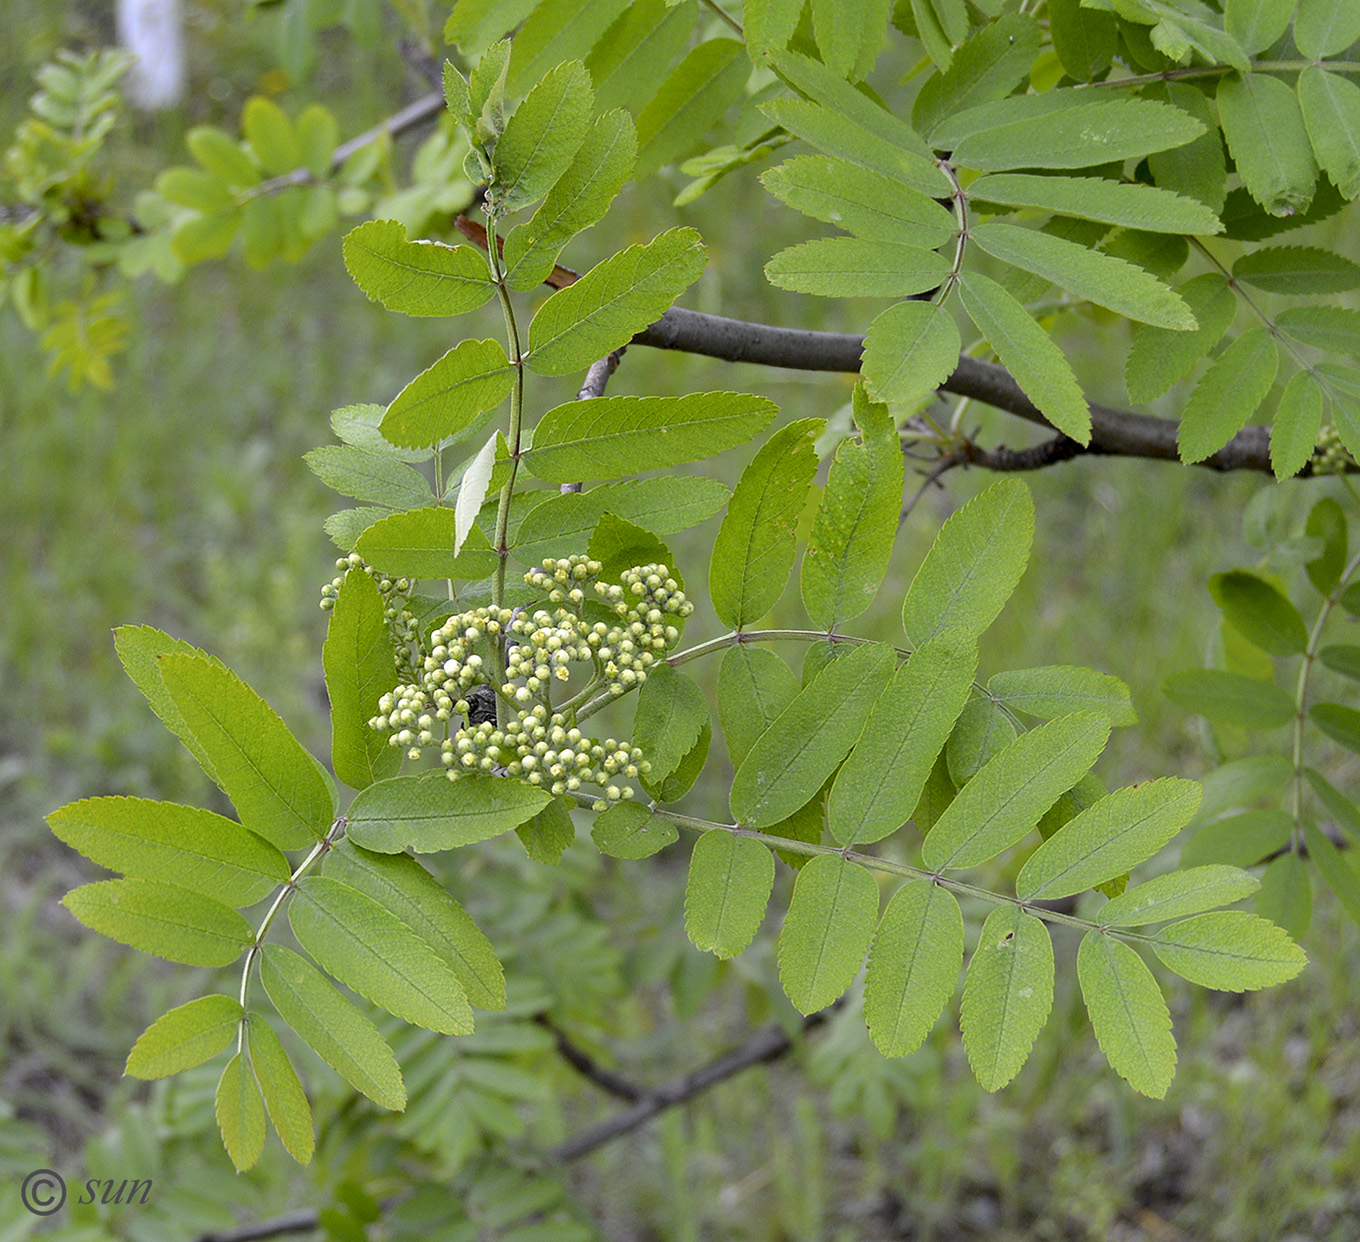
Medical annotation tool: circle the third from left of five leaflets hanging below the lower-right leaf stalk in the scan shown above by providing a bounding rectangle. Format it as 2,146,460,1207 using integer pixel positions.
864,880,963,1057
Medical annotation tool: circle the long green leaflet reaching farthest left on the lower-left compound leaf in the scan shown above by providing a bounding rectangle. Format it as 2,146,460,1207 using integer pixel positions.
48,794,289,907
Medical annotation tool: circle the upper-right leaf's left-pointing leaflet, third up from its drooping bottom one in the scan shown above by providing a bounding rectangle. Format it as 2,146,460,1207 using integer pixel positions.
760,155,959,250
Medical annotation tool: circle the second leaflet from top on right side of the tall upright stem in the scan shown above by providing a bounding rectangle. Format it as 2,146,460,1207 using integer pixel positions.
505,109,638,288
